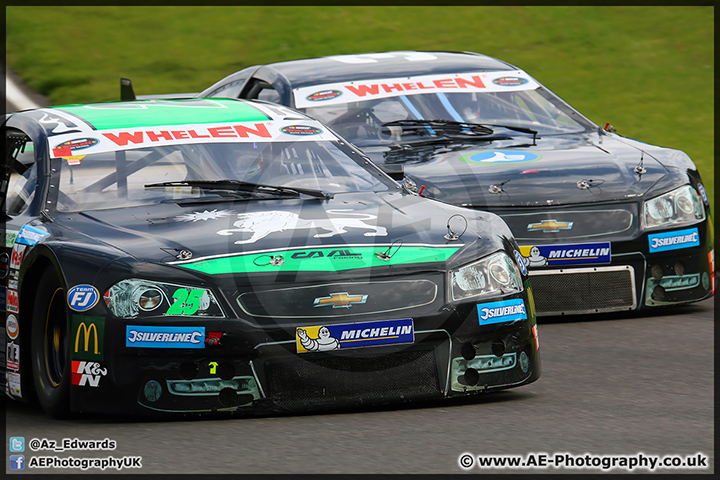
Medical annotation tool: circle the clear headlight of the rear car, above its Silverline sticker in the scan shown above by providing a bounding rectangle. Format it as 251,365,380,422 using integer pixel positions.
643,185,705,228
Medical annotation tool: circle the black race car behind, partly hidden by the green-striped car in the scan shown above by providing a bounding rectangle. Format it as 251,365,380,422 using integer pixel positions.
195,52,715,315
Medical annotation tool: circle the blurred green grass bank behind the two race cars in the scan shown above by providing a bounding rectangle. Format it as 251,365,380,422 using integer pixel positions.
6,6,715,210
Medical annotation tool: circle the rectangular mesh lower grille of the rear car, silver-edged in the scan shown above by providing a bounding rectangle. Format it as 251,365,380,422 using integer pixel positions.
530,266,637,315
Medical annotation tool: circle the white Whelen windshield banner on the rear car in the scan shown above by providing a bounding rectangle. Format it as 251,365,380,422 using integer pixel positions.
293,70,539,108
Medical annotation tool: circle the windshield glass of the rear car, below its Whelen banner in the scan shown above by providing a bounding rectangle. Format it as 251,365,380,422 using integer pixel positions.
300,88,597,147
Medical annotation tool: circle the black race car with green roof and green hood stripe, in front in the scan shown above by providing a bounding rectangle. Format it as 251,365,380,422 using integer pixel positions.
0,99,540,416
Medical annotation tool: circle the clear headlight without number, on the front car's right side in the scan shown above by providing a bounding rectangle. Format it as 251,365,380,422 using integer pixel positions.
450,252,522,301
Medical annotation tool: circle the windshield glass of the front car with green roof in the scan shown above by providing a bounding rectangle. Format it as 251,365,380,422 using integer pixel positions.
55,141,393,212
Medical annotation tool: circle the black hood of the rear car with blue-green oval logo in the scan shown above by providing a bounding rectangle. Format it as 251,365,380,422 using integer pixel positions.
365,132,668,208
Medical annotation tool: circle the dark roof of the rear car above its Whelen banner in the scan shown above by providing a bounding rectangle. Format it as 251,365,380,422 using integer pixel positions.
261,51,517,88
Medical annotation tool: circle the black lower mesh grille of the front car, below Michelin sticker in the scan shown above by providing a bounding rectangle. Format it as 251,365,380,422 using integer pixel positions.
265,350,440,403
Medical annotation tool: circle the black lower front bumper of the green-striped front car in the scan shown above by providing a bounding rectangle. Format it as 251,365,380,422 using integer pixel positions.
71,292,541,415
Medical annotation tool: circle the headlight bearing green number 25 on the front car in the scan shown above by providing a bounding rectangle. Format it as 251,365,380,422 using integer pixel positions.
105,278,225,318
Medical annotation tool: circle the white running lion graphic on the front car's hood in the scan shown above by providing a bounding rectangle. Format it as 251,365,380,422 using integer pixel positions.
217,210,387,245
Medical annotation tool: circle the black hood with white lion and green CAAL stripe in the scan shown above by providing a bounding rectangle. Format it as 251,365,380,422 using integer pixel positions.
55,192,511,274
